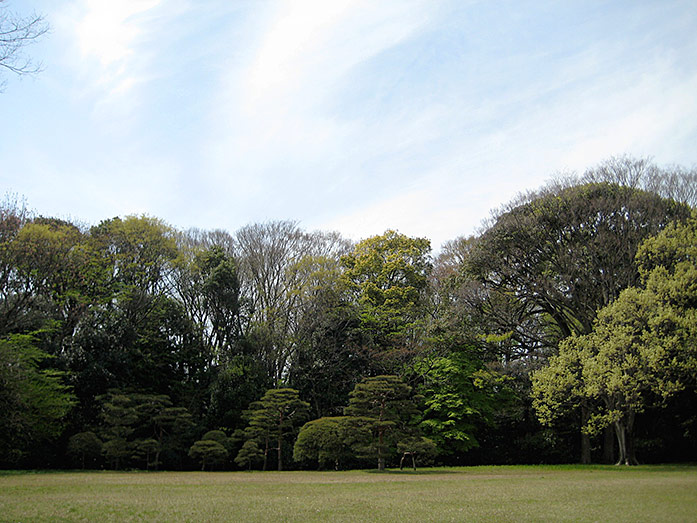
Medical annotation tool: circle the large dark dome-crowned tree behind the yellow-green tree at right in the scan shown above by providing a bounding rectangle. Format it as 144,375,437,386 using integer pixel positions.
463,182,690,463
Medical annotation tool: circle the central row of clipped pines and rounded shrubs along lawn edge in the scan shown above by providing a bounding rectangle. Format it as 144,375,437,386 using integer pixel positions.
190,375,436,470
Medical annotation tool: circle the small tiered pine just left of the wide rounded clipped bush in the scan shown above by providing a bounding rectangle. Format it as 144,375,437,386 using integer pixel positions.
241,388,309,470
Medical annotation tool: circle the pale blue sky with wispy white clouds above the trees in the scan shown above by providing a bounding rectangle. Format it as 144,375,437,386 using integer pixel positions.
0,0,697,250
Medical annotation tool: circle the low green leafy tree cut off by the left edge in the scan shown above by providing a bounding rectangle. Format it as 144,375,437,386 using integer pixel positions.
0,334,74,462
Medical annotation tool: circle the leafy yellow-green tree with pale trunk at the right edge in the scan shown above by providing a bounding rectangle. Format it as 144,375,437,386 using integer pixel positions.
533,214,697,465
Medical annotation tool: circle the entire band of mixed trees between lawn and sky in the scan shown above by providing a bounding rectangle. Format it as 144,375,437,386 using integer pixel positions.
0,157,697,470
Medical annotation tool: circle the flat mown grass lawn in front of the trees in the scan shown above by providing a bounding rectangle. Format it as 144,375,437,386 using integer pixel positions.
0,466,697,522
